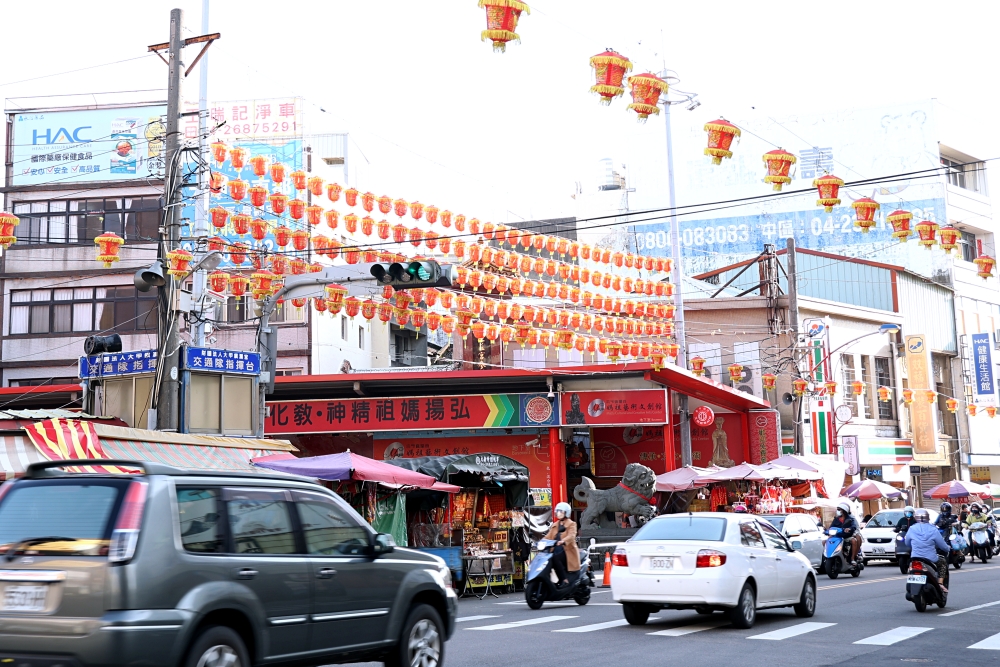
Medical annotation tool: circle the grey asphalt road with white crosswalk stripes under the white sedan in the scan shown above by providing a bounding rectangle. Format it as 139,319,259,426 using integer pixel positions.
350,561,1000,667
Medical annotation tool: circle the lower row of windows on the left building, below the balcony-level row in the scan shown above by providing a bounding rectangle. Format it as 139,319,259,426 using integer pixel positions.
10,287,157,335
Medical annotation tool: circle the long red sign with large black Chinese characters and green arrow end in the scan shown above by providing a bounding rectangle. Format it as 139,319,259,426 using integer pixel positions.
265,392,560,435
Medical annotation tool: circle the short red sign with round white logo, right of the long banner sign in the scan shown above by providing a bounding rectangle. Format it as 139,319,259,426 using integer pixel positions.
560,389,668,426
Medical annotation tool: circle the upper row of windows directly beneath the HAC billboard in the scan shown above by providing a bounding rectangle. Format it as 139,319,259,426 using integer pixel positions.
14,197,163,244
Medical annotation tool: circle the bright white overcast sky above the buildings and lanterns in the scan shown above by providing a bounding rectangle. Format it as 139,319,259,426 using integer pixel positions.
0,0,1000,227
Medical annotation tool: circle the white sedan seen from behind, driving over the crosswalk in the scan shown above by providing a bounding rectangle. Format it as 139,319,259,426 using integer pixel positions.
611,512,816,628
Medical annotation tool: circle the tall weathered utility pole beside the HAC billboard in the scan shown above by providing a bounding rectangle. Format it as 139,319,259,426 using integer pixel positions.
156,9,184,431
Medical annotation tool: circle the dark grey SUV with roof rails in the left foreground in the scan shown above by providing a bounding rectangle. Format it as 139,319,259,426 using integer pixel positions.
0,461,457,667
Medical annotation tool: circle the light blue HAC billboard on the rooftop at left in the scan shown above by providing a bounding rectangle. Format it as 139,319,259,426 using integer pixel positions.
8,105,167,186
